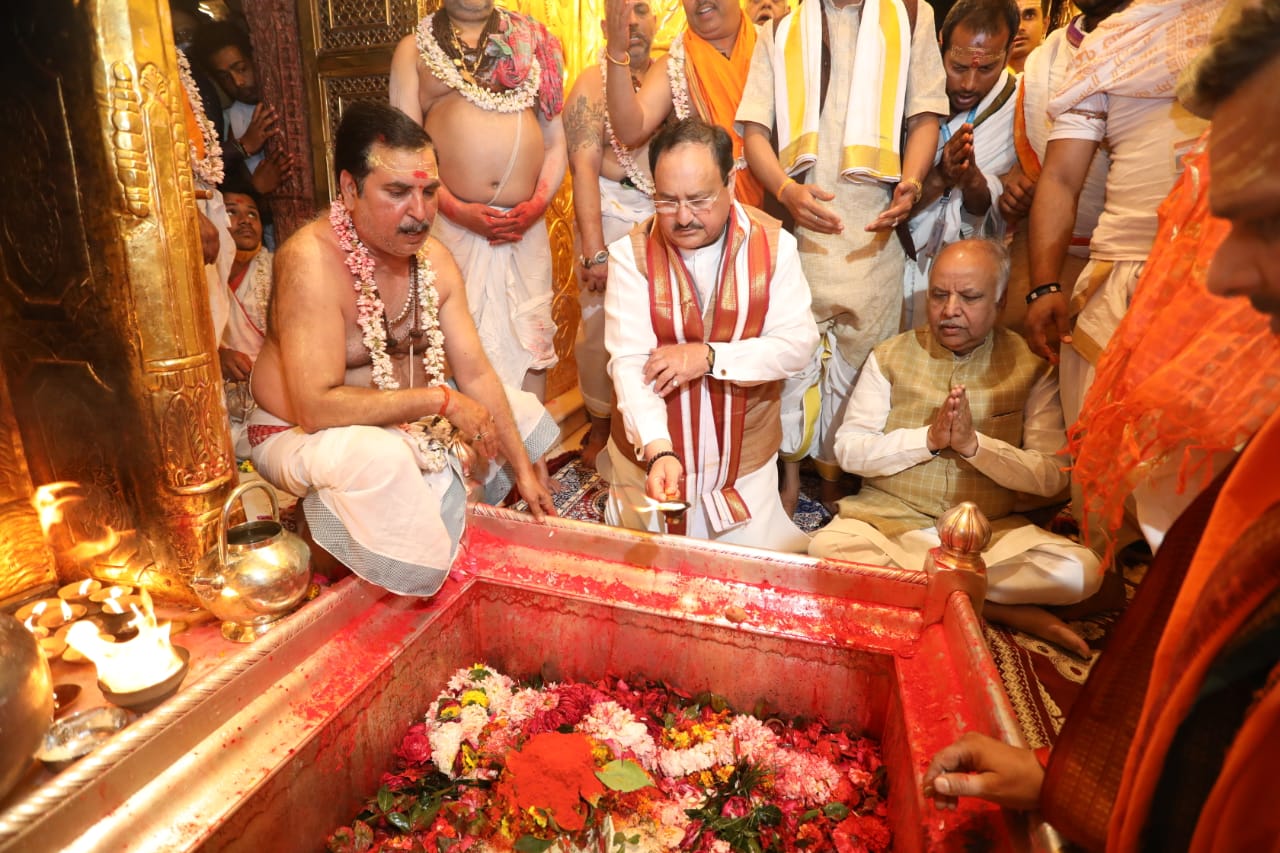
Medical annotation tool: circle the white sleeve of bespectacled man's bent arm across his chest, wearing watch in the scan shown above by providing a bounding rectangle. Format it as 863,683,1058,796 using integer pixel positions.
706,232,818,386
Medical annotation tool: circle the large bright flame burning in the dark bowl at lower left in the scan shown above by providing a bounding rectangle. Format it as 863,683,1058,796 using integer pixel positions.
67,590,182,693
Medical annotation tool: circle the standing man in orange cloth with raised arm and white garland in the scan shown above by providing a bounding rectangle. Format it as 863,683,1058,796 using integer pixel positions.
604,0,764,207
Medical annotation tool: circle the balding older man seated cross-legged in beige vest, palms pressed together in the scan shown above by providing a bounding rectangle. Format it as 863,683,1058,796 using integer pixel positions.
809,240,1101,605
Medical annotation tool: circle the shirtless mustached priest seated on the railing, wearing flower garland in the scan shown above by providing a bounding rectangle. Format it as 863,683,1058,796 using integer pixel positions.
248,102,557,596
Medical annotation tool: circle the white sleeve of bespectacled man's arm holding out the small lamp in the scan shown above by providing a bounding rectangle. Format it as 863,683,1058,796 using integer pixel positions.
604,236,671,448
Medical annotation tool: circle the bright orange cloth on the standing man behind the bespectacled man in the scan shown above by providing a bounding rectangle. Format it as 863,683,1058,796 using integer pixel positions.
685,14,764,207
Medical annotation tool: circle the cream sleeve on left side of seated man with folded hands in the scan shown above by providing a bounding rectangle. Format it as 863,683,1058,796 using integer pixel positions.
835,352,933,476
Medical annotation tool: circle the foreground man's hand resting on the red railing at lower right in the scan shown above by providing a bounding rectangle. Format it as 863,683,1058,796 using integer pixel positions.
924,731,1044,809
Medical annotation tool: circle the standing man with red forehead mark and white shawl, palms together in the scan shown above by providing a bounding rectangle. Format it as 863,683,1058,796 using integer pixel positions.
901,0,1018,330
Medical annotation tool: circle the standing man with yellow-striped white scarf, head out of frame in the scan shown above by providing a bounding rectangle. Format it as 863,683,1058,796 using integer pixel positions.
736,0,947,500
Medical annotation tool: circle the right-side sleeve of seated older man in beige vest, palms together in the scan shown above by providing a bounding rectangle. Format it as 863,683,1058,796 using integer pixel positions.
969,370,1070,497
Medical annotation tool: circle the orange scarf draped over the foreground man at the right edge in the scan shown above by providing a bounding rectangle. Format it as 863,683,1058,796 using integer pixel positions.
1107,412,1280,850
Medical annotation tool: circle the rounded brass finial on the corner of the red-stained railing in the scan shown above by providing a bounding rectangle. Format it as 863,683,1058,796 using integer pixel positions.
924,501,991,625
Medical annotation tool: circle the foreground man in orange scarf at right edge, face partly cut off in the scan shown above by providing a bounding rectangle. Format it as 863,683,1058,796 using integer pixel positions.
924,0,1280,853
